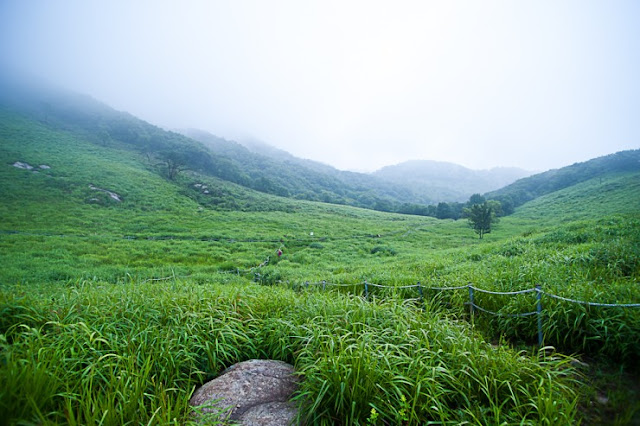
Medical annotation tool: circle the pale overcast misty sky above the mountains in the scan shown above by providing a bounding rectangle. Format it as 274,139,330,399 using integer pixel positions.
0,0,640,171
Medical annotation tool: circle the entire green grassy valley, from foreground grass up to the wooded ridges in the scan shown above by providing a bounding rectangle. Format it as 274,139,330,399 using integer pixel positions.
0,111,640,424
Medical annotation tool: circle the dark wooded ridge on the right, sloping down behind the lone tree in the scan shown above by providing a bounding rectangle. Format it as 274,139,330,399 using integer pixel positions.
485,149,640,211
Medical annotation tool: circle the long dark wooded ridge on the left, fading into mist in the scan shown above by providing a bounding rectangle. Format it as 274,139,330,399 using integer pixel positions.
0,76,440,215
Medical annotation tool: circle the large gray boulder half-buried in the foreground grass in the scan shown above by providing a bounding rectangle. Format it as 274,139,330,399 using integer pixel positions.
190,359,298,426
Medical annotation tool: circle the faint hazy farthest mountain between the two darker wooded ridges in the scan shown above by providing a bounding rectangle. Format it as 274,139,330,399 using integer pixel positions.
373,160,533,202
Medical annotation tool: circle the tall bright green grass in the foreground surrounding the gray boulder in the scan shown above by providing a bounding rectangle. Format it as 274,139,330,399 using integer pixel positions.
0,280,579,425
